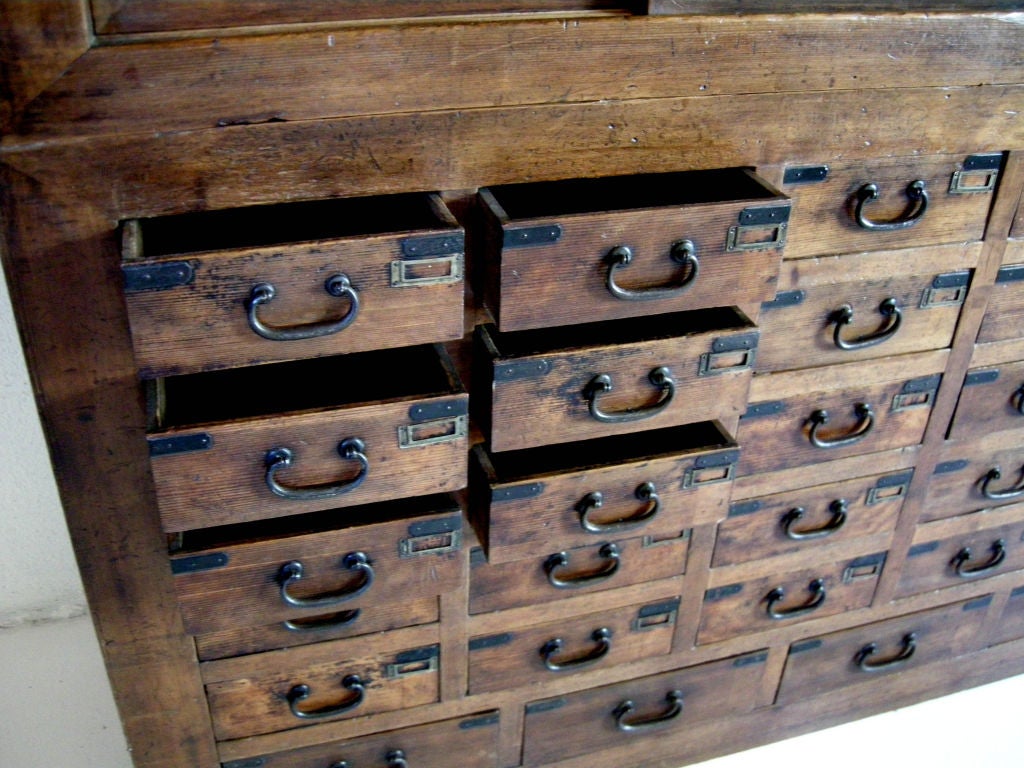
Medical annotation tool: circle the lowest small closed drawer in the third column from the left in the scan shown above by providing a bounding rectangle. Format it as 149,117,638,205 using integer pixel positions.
697,553,886,645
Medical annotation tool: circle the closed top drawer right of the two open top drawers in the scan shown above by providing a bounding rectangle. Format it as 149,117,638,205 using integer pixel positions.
782,153,1002,258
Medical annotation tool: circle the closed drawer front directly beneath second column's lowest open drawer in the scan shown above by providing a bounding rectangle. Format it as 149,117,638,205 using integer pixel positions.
469,530,690,613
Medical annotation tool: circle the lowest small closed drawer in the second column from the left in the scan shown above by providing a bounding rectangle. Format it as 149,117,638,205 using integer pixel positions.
469,596,680,693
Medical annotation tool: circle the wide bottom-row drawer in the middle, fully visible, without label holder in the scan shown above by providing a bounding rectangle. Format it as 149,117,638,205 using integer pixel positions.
522,651,768,766
